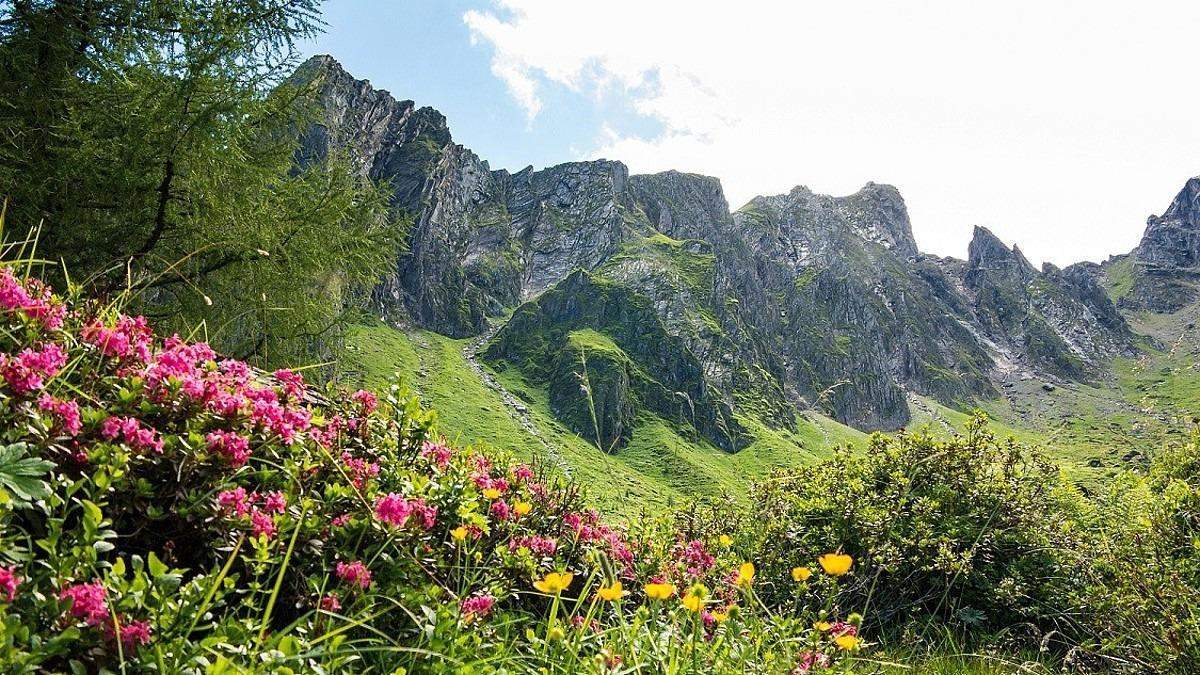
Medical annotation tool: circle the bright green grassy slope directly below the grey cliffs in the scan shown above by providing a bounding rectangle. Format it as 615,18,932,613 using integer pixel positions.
340,324,864,514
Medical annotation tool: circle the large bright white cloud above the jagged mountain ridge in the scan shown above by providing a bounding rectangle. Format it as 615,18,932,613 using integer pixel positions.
464,0,1200,263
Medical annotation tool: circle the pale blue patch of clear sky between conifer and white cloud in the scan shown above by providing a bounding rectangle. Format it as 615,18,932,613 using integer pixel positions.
297,0,661,178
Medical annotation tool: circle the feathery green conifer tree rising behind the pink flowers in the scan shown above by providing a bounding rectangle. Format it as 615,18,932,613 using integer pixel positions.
0,0,396,363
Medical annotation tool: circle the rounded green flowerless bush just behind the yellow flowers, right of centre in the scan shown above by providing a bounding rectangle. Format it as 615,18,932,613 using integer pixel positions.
746,417,1086,631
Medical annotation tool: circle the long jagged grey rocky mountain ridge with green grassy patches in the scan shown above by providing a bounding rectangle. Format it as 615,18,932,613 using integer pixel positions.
295,56,1200,452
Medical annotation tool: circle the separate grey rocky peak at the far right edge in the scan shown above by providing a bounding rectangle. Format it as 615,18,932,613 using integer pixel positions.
1110,177,1200,312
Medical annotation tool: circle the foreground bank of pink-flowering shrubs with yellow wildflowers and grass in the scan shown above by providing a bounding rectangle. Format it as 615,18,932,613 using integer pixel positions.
0,265,862,673
